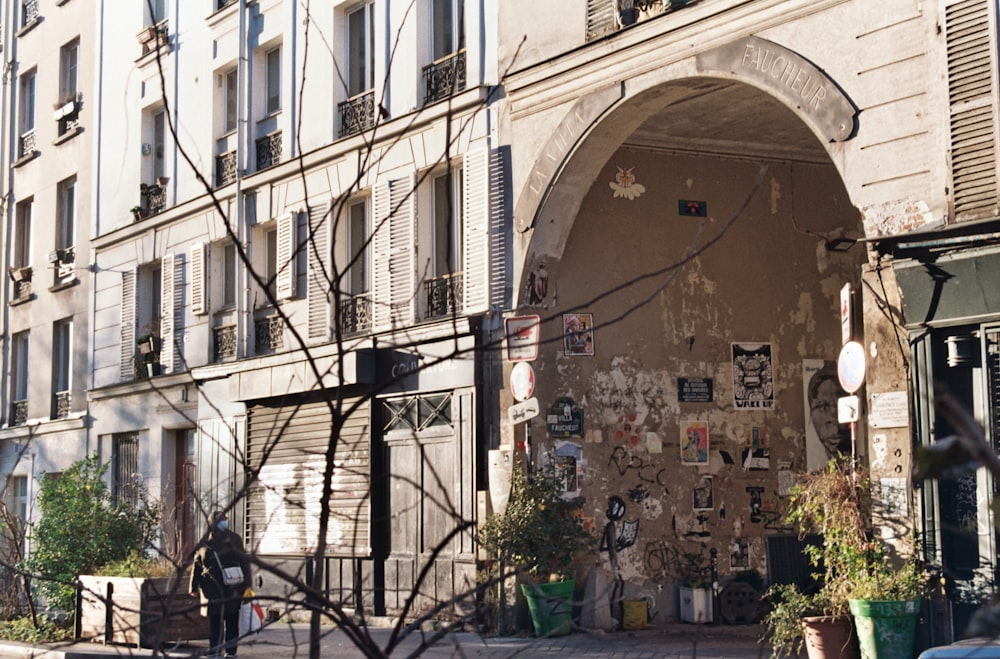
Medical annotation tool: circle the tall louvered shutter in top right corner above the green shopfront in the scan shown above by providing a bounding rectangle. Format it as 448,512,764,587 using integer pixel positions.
945,0,997,221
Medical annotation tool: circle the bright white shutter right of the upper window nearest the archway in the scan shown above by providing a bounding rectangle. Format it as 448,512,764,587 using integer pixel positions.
462,149,490,314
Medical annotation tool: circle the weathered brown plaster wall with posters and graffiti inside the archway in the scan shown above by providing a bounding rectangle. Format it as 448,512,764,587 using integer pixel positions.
529,148,864,617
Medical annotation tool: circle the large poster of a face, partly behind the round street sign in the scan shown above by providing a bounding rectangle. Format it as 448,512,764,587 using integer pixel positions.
802,359,851,471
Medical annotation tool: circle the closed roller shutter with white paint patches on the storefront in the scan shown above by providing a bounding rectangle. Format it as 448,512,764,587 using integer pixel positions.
247,399,371,557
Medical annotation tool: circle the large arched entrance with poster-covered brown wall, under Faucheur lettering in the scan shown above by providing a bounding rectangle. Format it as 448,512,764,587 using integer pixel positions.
504,42,865,625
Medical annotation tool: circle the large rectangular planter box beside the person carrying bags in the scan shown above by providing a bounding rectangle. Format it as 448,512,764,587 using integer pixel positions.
79,575,208,648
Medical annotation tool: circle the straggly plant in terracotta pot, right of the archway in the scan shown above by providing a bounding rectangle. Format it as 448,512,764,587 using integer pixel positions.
764,461,869,658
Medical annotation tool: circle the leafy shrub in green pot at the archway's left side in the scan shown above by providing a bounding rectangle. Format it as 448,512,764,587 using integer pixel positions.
479,465,597,636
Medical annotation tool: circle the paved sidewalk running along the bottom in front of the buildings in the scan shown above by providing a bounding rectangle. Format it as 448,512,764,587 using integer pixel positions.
0,623,770,659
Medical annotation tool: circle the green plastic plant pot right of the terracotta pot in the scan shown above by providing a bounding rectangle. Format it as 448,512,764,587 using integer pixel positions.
849,600,920,659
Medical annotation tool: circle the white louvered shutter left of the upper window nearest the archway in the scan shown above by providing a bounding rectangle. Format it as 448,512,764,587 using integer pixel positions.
372,176,416,330
